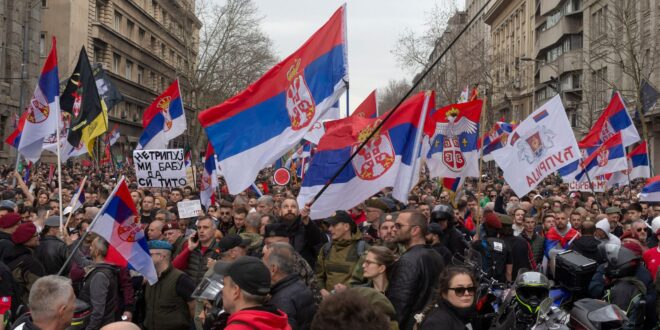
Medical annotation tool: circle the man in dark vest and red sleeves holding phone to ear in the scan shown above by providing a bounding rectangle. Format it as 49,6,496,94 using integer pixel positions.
172,216,219,285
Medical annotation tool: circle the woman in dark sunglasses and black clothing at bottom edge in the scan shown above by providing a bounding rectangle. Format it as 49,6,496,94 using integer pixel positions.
416,266,478,330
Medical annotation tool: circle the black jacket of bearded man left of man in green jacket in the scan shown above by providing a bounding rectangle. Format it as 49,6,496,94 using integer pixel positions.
287,217,326,269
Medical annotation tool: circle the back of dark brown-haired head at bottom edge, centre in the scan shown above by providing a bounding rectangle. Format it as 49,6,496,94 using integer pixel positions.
311,289,390,330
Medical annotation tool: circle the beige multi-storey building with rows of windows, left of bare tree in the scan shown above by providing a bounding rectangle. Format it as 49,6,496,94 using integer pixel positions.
41,0,201,153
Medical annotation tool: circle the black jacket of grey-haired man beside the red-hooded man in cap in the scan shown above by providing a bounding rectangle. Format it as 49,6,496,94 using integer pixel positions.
270,274,317,330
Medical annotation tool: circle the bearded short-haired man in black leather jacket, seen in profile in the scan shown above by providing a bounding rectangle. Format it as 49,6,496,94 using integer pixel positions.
385,210,444,329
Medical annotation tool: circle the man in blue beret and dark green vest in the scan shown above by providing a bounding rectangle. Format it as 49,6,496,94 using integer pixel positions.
143,240,195,330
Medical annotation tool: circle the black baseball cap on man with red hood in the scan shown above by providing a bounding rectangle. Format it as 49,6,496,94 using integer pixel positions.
213,256,270,296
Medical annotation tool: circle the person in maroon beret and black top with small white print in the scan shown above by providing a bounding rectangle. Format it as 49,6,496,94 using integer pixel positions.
471,212,513,283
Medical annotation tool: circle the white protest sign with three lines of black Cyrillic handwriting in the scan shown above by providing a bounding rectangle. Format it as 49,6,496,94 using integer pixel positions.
133,149,188,188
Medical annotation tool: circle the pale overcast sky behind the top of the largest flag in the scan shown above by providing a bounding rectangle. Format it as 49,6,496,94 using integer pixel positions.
254,0,463,113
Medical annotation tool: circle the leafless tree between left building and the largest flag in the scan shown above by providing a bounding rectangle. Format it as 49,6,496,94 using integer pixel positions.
180,0,277,150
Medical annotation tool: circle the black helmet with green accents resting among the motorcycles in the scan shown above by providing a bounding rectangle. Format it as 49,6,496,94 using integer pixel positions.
515,272,550,314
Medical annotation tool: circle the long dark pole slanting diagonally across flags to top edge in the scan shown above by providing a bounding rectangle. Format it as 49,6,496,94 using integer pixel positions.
308,0,490,206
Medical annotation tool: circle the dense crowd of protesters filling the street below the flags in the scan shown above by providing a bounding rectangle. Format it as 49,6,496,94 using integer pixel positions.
0,164,660,330
